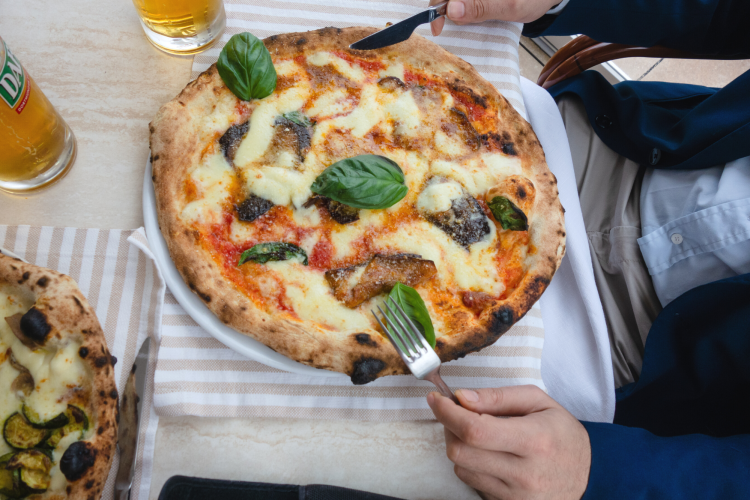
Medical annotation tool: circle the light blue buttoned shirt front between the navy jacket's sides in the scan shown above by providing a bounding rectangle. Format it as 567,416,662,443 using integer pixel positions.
638,157,750,306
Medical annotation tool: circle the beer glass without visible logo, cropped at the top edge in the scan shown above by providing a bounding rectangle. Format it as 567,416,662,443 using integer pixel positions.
133,0,227,54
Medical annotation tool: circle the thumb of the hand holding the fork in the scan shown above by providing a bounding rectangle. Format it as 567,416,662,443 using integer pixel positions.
456,385,558,417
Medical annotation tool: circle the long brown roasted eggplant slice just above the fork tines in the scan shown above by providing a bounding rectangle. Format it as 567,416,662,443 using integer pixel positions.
325,254,437,309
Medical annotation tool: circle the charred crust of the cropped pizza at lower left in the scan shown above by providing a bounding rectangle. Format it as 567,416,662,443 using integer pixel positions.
0,253,118,500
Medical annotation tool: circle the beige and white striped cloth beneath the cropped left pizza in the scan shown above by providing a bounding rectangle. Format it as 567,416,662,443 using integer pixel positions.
0,226,160,500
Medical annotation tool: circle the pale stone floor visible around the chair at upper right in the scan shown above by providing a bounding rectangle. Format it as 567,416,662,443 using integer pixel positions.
518,37,750,87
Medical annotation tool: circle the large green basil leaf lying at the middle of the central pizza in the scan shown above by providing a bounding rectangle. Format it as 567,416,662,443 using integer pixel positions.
311,155,409,208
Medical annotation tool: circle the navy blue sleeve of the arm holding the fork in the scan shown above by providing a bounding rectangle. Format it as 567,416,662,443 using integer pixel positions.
582,422,750,500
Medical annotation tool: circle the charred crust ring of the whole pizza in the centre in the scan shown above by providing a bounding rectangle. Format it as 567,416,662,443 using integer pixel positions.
150,27,565,384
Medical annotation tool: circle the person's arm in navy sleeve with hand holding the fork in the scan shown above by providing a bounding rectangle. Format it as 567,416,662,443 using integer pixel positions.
427,386,750,500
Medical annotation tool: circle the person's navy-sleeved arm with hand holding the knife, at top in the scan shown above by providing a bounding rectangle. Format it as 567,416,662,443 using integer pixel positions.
430,0,750,55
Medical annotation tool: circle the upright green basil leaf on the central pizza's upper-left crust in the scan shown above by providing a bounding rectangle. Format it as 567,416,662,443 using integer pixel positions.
216,33,276,101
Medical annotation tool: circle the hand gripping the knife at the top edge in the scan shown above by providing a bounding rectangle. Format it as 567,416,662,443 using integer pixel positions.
430,0,562,36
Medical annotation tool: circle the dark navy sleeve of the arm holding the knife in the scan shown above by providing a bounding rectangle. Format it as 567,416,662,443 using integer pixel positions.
523,0,750,56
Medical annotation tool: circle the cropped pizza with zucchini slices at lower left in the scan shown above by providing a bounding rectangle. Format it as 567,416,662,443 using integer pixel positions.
0,254,117,499
